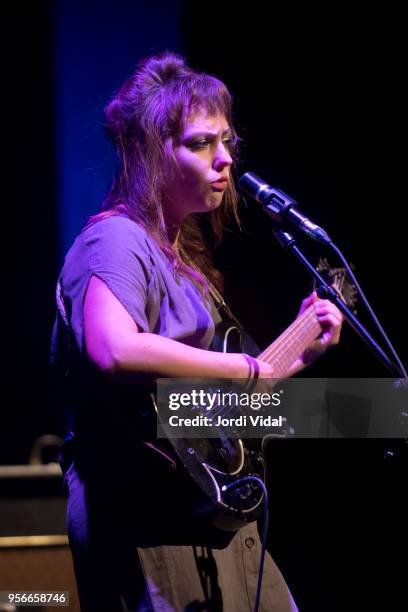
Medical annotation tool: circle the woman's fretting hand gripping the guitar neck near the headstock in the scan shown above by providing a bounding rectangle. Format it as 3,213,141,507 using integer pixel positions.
298,291,344,366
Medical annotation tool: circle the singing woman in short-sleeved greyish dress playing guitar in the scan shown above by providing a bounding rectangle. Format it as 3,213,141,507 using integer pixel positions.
53,53,342,612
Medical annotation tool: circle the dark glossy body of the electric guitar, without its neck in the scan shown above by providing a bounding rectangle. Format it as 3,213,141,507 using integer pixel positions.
149,320,270,531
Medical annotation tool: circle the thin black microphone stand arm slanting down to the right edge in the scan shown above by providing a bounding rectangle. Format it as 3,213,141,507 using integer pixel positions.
273,224,404,378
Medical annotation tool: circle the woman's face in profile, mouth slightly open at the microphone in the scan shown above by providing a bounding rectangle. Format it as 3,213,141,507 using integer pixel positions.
164,111,232,223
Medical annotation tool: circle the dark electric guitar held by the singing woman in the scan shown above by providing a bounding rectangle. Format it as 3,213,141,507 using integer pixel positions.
149,260,356,530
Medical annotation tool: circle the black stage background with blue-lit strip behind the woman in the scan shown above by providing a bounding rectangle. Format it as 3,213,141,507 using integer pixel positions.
0,1,408,611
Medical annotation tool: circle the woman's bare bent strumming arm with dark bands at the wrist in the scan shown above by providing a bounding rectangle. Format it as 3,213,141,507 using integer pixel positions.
83,276,272,379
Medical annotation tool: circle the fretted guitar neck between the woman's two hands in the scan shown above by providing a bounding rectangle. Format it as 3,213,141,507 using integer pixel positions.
258,305,322,378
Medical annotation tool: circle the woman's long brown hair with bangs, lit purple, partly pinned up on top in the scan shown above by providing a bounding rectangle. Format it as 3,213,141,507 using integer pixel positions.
88,52,239,291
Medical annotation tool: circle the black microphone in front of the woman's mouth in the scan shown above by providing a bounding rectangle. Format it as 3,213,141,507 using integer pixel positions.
238,172,332,244
